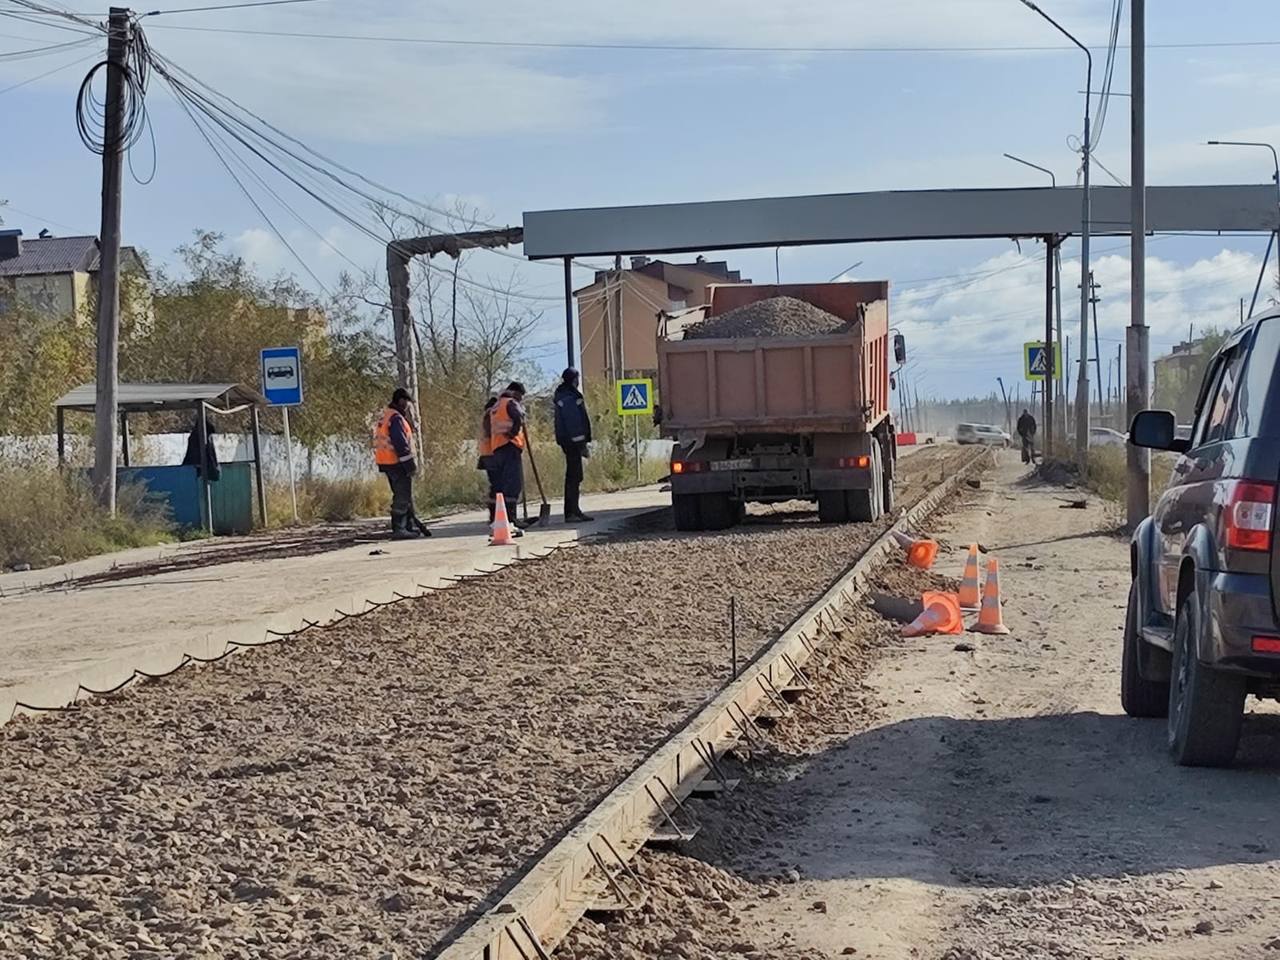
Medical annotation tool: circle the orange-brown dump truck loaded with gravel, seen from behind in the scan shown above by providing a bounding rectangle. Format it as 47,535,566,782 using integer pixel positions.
655,282,906,530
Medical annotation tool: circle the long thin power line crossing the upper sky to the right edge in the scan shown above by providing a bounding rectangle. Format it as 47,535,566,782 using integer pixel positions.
140,24,1280,54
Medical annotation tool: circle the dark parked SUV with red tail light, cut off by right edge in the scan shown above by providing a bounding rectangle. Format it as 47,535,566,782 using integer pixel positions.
1120,311,1280,767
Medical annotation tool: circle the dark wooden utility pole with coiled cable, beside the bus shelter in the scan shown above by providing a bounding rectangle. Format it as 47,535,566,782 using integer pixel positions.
93,6,129,515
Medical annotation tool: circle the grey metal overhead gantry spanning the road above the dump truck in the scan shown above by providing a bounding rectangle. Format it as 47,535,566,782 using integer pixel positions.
524,183,1280,468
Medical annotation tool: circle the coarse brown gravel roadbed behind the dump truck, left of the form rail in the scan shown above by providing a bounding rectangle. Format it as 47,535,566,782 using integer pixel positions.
0,447,972,959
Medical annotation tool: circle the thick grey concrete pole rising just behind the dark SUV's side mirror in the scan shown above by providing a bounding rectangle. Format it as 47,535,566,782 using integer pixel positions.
1125,0,1151,530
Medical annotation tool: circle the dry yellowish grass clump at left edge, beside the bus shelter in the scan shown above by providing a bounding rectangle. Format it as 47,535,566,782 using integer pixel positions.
0,462,174,567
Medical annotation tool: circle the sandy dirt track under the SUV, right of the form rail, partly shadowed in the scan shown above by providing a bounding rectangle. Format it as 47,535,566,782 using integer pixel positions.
566,456,1280,960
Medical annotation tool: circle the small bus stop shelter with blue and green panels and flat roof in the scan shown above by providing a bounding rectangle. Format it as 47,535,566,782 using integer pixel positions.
54,383,268,534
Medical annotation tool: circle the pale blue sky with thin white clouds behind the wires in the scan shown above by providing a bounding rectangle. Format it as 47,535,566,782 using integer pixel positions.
0,0,1280,398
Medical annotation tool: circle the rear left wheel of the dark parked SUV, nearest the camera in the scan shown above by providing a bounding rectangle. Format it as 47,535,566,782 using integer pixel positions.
1169,590,1245,767
